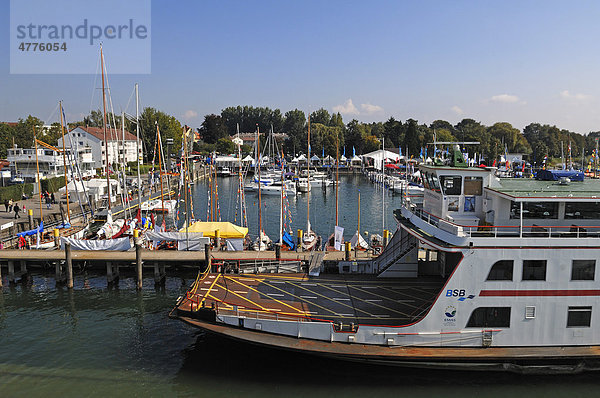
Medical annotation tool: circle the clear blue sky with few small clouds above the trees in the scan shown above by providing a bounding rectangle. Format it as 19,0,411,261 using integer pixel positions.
0,0,600,133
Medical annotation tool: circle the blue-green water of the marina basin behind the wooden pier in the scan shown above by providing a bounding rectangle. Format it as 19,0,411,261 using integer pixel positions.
192,173,400,241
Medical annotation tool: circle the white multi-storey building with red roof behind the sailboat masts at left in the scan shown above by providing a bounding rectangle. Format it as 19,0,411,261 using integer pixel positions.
58,126,143,168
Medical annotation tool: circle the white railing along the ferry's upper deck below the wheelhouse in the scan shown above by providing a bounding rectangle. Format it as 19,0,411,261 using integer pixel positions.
412,209,600,238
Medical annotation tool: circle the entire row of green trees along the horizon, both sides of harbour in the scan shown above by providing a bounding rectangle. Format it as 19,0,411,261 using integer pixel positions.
0,106,600,164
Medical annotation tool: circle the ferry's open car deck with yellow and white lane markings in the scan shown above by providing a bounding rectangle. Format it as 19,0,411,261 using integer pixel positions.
179,274,444,326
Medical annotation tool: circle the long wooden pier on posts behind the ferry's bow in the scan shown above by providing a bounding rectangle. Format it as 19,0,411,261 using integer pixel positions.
0,245,372,289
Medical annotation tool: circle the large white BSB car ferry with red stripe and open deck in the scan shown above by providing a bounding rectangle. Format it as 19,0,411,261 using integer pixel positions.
172,147,600,373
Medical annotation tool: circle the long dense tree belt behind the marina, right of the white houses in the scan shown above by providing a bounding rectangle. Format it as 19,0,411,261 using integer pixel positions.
198,106,600,163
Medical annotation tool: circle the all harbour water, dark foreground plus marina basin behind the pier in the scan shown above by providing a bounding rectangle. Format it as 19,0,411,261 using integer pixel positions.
0,176,600,398
